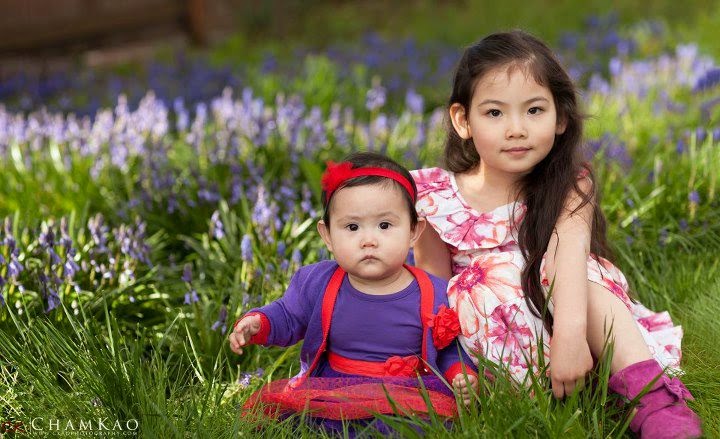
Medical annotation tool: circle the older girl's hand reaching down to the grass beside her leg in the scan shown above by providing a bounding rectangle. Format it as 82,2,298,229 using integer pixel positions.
550,331,593,398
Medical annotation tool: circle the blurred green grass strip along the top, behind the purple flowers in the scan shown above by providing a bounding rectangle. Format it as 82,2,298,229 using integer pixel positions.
212,0,720,60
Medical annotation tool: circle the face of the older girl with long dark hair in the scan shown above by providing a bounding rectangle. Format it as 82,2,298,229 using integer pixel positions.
450,67,565,179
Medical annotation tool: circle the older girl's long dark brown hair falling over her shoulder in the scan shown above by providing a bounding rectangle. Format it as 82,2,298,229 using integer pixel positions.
445,31,610,334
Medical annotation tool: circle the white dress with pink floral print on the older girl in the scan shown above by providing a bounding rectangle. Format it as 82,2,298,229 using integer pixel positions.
411,168,682,382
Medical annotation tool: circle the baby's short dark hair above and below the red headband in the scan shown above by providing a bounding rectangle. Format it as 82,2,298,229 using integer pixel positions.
322,152,418,229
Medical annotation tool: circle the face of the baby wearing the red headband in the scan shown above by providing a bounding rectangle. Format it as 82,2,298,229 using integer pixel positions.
323,184,417,290
